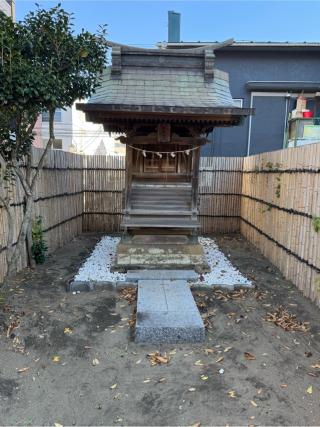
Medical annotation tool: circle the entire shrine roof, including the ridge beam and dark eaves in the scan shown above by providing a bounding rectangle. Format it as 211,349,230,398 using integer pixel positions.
77,40,251,130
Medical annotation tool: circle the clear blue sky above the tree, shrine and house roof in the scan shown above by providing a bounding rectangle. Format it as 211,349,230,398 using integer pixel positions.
16,0,320,47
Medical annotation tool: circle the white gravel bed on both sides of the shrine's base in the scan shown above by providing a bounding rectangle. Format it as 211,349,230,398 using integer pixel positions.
74,236,251,286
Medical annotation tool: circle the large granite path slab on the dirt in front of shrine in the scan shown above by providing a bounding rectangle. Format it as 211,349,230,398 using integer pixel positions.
135,280,205,344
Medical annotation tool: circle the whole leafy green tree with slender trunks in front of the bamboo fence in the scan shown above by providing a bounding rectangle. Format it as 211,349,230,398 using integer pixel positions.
0,4,107,286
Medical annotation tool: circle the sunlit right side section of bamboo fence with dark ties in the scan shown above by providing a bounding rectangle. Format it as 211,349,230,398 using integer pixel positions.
240,144,320,305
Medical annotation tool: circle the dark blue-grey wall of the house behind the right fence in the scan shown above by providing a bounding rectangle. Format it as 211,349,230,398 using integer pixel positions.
202,47,320,156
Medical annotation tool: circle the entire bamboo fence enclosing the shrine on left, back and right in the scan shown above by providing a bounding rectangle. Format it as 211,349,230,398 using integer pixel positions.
0,144,320,305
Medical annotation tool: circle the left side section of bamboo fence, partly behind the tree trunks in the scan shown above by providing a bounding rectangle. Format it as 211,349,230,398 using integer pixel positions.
0,149,83,282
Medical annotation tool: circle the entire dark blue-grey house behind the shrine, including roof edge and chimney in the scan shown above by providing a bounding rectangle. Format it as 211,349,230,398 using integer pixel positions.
158,12,320,156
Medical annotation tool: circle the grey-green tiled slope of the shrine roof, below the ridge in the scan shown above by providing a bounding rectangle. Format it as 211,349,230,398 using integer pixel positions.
89,67,235,108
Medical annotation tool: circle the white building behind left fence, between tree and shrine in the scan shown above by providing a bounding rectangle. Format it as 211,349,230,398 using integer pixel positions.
34,105,125,155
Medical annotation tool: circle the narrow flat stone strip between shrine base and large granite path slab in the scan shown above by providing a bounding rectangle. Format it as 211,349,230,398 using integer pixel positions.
126,270,199,281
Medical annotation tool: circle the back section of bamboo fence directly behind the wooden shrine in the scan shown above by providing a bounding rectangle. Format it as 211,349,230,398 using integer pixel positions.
83,156,243,233
